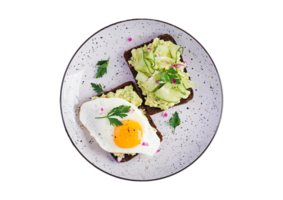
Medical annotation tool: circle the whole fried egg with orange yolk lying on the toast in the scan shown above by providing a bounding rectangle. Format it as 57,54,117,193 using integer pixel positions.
79,98,160,156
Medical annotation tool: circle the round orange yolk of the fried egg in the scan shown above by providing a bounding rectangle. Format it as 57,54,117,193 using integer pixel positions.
114,120,142,148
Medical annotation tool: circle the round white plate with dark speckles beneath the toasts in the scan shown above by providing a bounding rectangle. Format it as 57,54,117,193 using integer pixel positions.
58,18,225,182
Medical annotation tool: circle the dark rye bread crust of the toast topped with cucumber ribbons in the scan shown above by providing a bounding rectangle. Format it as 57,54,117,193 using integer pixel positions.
124,34,194,115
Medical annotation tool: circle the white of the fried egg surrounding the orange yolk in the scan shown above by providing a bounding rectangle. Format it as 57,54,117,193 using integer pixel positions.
79,98,160,156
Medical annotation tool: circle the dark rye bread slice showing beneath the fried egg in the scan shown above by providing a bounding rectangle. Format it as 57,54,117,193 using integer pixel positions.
97,81,162,162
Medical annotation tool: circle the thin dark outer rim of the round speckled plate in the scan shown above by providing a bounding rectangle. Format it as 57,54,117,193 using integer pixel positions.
58,18,226,182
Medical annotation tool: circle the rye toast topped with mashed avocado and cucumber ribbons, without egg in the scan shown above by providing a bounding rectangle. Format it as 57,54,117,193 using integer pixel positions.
124,34,195,115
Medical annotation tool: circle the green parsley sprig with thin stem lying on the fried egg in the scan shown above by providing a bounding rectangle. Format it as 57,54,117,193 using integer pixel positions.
95,105,131,126
